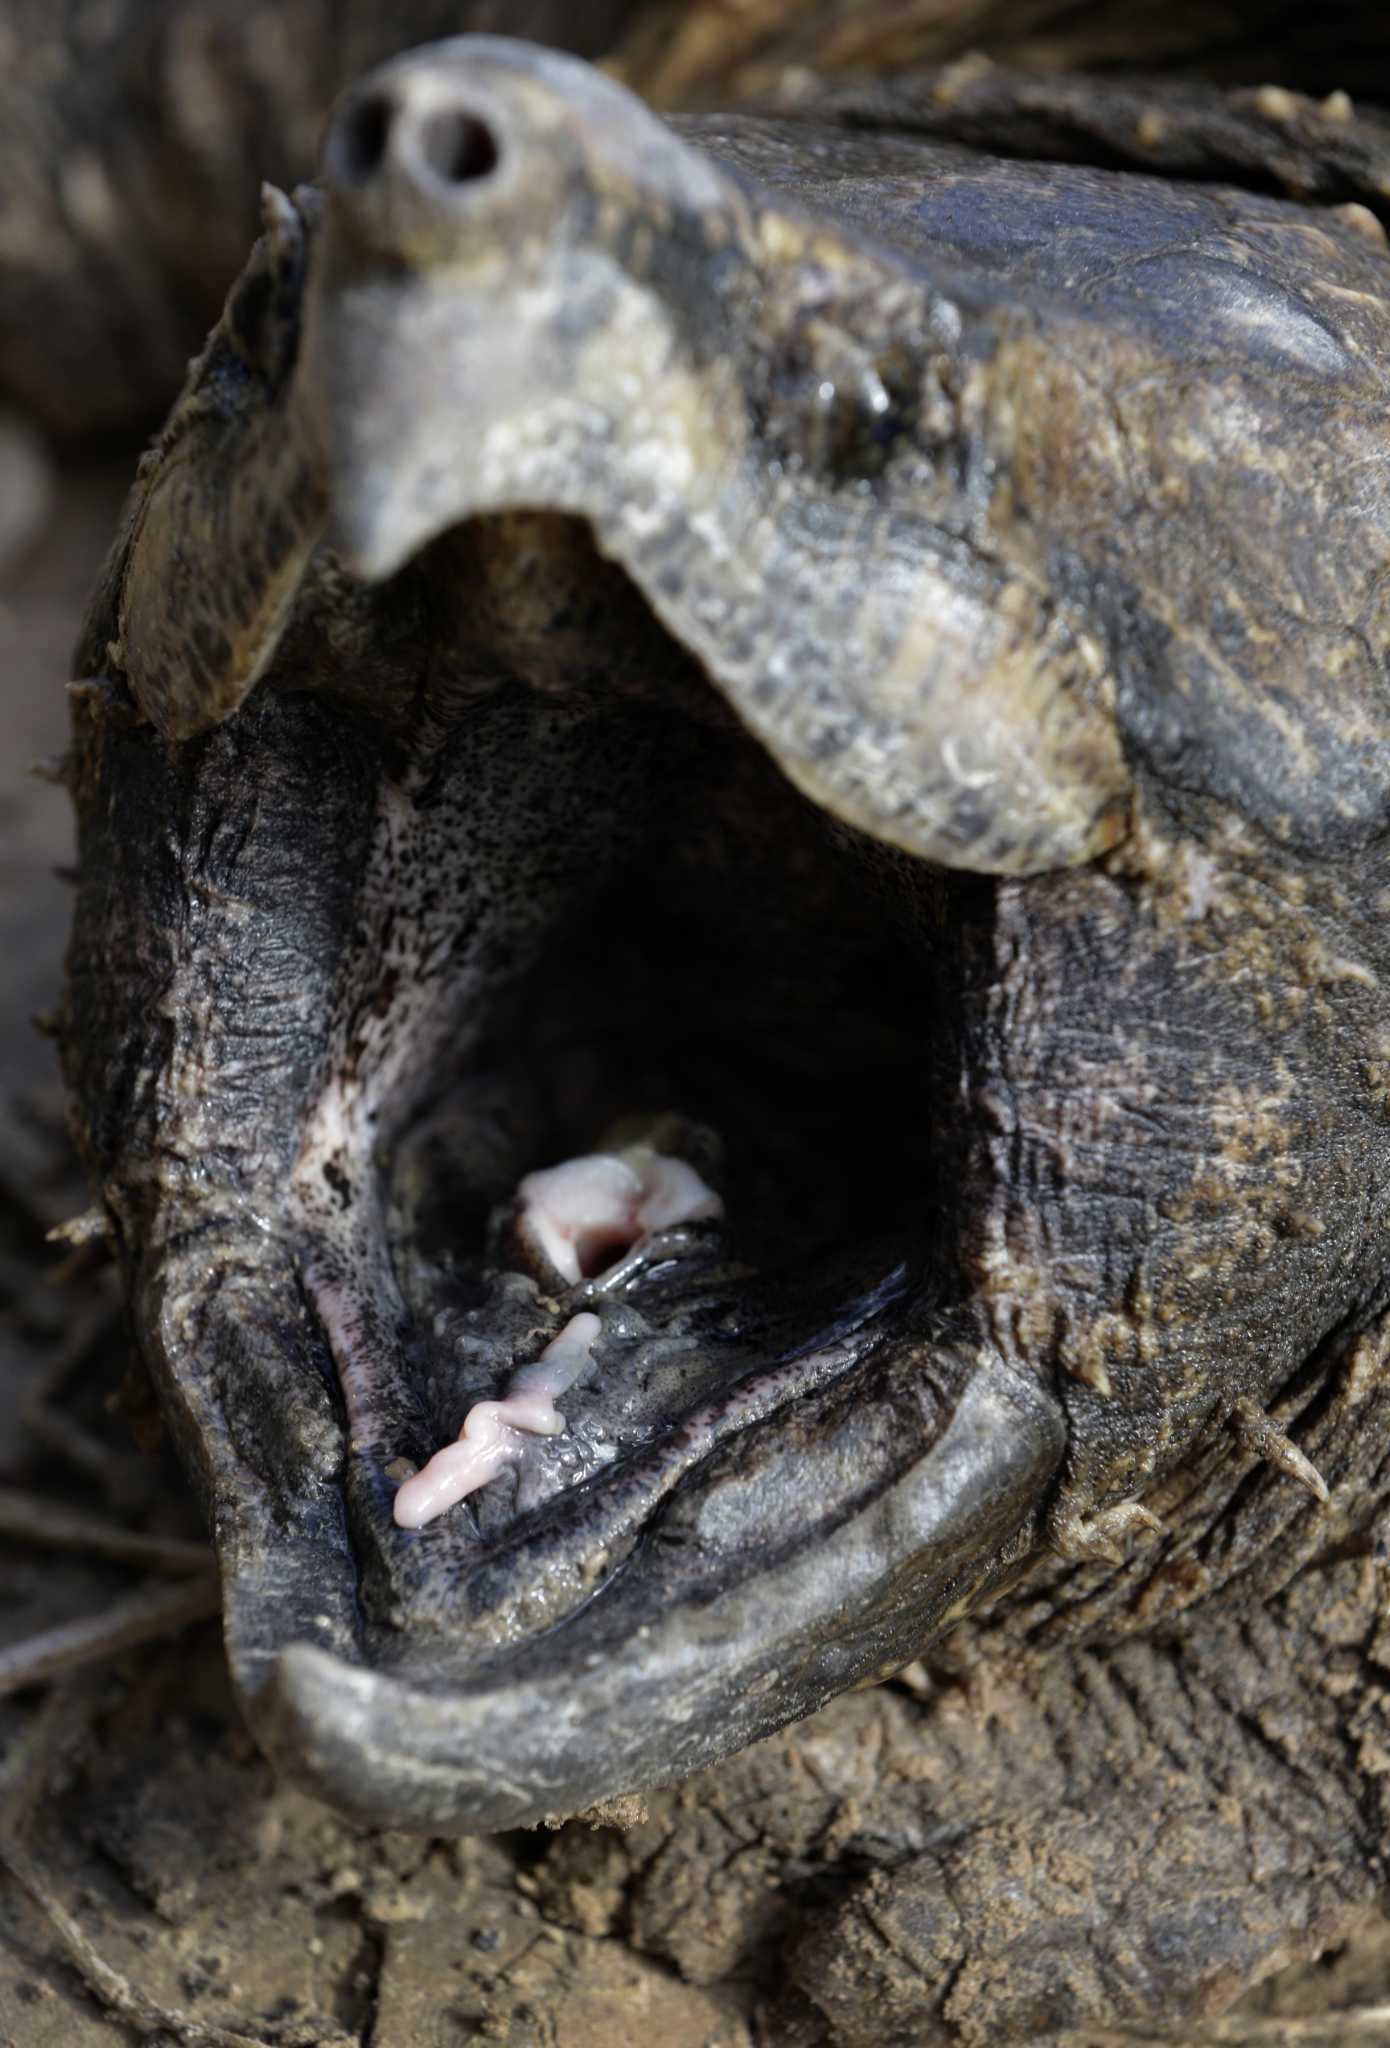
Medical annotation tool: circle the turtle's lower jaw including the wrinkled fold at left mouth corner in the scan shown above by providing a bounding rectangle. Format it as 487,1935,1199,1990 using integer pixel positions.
127,958,1065,1833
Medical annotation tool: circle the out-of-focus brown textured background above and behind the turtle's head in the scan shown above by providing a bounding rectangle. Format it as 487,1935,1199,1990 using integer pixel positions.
10,0,1390,440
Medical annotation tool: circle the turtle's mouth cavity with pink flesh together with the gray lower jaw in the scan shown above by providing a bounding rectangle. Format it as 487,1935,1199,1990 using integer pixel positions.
211,536,1060,1827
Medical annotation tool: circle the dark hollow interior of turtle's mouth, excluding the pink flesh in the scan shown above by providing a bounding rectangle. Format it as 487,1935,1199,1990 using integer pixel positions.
305,520,958,1622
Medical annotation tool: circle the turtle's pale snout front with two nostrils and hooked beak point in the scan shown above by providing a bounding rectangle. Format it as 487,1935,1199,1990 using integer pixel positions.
299,37,739,582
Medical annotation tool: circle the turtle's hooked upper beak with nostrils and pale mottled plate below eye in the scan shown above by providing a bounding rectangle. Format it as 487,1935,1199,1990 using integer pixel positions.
299,37,1130,872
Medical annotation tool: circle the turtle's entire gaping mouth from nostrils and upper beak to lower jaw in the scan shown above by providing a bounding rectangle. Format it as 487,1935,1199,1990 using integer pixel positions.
78,41,1128,1829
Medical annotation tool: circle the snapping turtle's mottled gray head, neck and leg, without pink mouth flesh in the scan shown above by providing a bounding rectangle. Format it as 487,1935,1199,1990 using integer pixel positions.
66,41,1390,2042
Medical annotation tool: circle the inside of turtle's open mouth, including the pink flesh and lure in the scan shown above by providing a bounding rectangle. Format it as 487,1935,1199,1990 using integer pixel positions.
295,520,966,1630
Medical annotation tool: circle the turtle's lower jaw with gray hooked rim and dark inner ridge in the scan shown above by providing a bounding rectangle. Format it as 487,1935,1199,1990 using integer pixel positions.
227,1228,1062,1831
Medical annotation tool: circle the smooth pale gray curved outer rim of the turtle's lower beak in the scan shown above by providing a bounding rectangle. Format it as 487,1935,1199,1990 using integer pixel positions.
241,1354,1065,1833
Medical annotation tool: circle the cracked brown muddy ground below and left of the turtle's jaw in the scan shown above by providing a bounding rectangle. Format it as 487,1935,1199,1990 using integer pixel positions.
0,457,1390,2048
